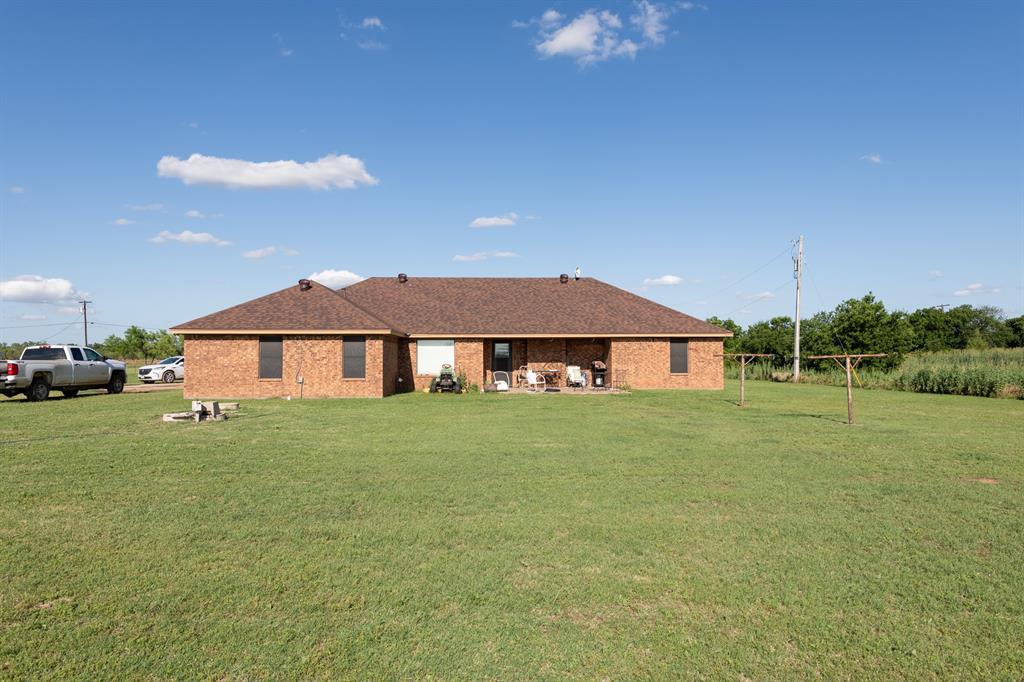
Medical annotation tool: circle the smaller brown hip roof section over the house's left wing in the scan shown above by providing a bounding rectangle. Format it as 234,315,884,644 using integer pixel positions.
172,282,392,333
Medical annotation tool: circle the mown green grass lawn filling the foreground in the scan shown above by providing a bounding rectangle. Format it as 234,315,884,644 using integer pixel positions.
0,383,1024,680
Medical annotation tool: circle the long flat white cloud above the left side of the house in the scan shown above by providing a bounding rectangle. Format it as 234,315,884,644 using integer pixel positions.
157,154,380,189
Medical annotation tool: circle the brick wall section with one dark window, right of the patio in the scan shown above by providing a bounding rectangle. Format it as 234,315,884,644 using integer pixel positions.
608,338,725,389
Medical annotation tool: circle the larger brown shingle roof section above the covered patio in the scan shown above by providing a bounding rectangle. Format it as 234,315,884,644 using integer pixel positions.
339,278,731,337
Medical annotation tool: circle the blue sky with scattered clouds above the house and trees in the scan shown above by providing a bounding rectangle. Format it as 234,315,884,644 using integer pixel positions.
0,0,1024,342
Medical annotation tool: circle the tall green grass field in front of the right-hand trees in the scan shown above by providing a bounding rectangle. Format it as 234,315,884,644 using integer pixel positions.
726,348,1024,398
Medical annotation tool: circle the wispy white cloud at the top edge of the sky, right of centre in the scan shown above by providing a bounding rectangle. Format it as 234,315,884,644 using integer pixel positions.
528,0,675,67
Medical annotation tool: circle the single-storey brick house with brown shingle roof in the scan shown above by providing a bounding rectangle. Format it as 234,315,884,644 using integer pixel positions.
171,274,731,397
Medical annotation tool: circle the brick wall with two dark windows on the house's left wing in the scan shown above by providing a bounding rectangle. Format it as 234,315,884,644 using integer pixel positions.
184,335,385,398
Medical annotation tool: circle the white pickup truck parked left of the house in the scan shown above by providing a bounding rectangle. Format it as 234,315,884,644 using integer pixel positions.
0,345,127,400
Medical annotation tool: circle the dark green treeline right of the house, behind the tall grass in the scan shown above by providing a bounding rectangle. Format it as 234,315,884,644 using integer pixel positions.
708,294,1024,370
